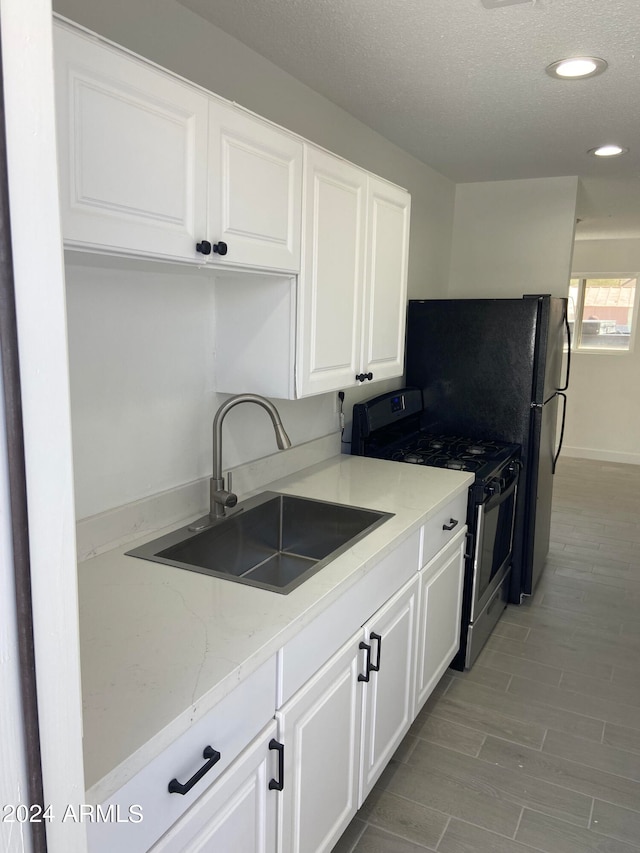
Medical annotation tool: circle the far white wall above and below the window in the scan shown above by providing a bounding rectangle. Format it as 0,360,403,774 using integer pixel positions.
564,240,640,465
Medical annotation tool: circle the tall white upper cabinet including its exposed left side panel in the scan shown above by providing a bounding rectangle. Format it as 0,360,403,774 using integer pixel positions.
216,144,411,399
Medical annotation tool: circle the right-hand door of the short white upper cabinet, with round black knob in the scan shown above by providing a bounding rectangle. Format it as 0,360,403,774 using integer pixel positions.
207,101,302,273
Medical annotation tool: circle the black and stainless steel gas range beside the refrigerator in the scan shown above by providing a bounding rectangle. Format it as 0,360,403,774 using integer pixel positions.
351,388,520,670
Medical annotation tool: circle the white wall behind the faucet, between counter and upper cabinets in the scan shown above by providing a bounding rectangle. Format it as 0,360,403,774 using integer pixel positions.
66,252,340,524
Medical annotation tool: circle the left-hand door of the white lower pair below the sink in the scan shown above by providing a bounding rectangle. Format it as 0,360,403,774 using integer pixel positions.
276,632,363,853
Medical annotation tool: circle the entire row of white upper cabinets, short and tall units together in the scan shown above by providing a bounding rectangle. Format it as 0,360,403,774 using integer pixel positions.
54,21,410,399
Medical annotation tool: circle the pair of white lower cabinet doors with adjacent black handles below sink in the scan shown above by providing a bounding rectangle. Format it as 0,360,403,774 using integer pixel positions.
276,576,418,853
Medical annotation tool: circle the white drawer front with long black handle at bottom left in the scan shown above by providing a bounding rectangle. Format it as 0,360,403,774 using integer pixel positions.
88,656,276,853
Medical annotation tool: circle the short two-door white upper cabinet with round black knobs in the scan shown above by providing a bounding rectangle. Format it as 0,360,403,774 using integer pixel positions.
55,25,302,272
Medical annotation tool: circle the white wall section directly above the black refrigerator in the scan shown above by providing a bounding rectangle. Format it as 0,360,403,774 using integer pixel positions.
449,177,578,298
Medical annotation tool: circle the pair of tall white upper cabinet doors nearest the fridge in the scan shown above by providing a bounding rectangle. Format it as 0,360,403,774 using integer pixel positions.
296,145,410,397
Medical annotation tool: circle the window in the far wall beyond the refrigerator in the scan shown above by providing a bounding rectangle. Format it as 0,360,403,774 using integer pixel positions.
569,276,638,352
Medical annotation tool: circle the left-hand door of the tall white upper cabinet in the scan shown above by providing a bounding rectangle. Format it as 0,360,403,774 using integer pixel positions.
296,146,367,397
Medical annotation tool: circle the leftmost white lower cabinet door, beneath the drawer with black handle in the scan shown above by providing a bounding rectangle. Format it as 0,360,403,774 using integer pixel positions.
152,720,279,853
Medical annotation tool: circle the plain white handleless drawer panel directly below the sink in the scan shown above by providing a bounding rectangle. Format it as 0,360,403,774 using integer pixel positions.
278,522,420,707
